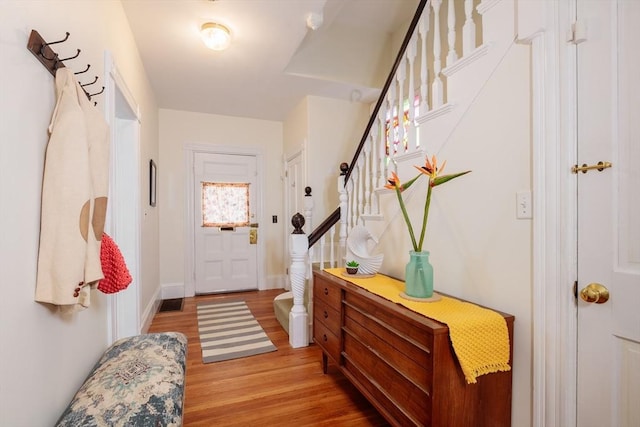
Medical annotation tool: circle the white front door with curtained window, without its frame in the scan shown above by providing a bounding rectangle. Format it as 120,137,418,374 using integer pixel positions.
193,153,258,294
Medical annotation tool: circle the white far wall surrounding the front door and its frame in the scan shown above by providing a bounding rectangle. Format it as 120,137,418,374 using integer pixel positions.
158,109,285,287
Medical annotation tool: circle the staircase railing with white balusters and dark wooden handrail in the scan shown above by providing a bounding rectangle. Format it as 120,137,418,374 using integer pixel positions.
289,0,496,348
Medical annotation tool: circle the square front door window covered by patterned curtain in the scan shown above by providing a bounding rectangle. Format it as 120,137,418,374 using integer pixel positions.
202,182,249,227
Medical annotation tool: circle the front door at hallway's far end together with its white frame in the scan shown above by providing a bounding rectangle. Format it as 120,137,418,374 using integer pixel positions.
184,144,266,297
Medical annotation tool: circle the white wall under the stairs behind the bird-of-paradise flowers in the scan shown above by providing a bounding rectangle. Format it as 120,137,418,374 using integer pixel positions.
380,45,533,426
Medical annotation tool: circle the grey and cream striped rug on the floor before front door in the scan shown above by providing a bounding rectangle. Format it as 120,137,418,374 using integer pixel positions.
197,301,277,363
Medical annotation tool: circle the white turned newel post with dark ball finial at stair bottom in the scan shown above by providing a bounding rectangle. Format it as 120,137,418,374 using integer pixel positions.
289,213,309,348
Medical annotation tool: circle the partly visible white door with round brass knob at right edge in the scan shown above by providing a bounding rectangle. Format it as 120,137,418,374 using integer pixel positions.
576,0,640,427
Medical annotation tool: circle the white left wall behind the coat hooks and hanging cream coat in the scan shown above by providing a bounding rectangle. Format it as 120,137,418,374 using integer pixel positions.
0,0,158,427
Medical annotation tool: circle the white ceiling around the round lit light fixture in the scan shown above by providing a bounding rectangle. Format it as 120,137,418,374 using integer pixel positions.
122,0,417,121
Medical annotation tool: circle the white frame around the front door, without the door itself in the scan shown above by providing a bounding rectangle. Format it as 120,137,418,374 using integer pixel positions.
183,143,266,297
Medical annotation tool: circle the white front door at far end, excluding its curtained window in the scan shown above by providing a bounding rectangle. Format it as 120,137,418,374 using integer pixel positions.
193,153,258,294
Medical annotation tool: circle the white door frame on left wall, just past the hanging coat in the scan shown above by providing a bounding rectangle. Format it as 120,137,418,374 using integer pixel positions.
104,51,142,344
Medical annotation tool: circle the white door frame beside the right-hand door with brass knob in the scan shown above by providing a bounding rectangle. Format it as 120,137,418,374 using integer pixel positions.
518,0,577,427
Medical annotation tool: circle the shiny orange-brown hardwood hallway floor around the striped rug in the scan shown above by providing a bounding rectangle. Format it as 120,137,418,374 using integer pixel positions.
149,289,388,427
